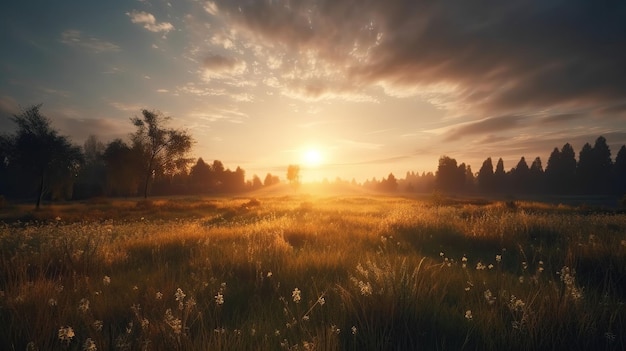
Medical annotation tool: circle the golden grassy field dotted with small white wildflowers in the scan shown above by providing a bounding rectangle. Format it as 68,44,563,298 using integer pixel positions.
0,194,626,350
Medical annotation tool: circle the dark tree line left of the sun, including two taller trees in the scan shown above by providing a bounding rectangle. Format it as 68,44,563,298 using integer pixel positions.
0,105,280,208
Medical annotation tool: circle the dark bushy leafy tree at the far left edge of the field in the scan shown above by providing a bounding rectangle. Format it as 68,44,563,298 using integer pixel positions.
4,105,83,209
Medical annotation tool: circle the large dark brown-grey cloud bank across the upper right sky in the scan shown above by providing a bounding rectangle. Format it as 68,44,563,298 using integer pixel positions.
211,0,626,112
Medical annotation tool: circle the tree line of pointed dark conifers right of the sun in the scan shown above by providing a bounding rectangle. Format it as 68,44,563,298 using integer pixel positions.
356,136,626,196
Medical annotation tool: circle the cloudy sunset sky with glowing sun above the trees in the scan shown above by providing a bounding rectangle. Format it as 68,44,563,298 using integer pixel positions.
0,0,626,182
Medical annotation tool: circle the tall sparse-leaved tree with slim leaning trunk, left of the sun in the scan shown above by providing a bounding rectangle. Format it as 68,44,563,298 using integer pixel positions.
131,109,193,198
